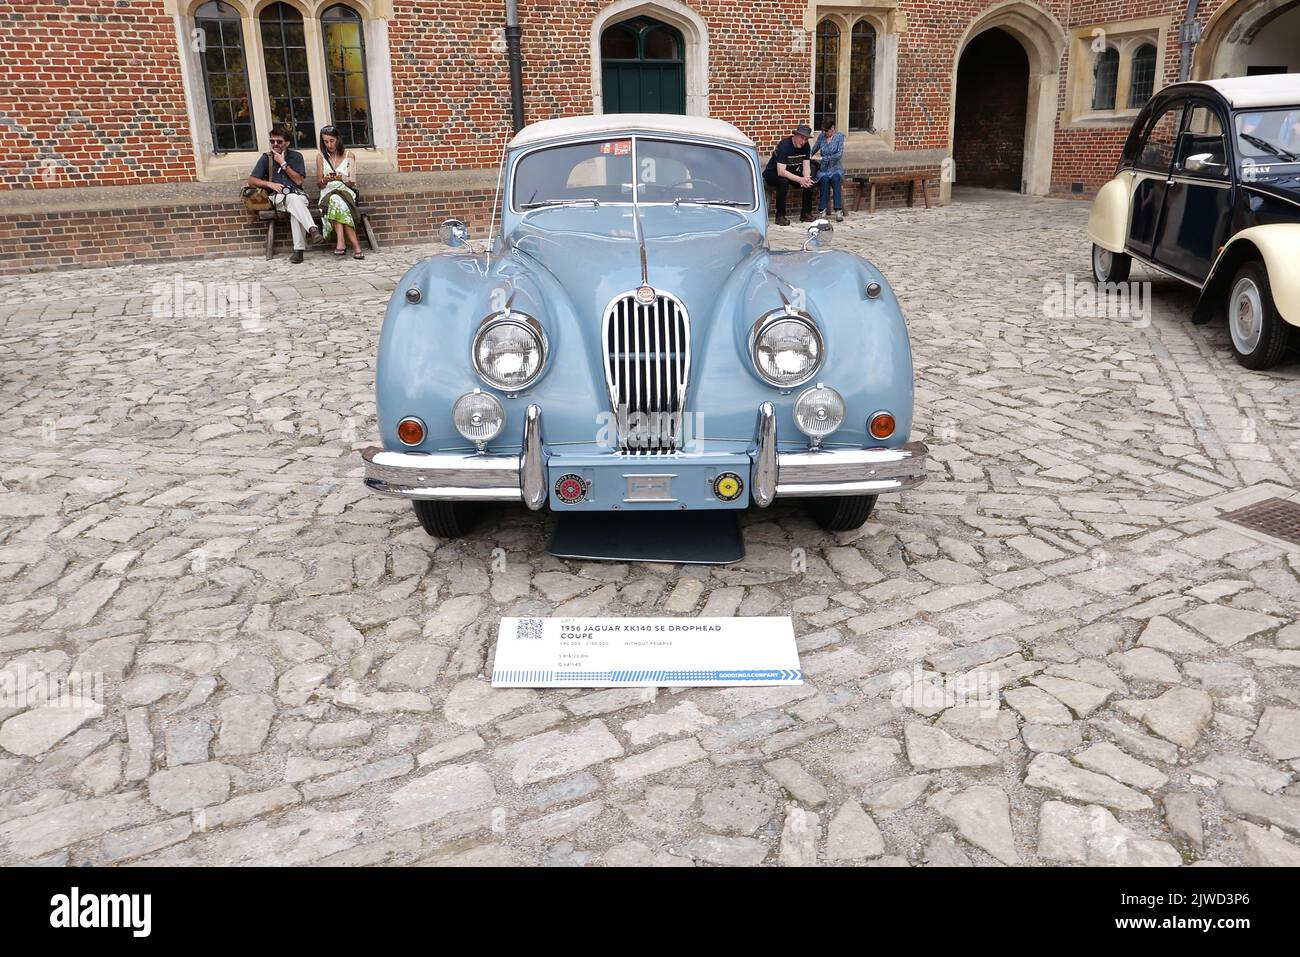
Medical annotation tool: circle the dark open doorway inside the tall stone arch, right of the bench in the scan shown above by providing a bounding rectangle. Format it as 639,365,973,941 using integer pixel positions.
953,27,1030,191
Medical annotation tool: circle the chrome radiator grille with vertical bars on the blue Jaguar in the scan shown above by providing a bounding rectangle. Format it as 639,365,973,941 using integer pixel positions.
602,293,690,452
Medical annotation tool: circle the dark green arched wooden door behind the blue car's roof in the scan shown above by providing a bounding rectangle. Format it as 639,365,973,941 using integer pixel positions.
601,17,686,113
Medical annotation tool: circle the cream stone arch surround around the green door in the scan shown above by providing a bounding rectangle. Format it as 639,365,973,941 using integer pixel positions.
592,0,709,116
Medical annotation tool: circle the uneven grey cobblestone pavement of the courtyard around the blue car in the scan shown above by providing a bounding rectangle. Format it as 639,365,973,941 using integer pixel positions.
0,194,1300,866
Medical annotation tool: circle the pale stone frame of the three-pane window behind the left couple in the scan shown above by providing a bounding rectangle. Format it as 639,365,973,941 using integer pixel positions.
164,0,398,182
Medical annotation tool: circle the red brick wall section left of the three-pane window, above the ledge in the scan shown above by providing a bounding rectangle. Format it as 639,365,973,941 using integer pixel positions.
0,0,194,190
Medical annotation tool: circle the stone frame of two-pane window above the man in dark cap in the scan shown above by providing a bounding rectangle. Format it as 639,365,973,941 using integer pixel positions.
803,0,907,148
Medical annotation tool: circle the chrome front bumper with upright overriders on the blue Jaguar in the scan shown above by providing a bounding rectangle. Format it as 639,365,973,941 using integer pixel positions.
361,402,930,510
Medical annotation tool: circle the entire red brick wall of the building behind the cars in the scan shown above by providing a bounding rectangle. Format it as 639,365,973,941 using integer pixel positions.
0,0,1268,268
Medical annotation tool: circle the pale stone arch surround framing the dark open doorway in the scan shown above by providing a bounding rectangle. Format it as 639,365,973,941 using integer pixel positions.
944,0,1066,196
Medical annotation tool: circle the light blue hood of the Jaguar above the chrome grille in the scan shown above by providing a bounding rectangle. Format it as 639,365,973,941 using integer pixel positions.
508,205,763,328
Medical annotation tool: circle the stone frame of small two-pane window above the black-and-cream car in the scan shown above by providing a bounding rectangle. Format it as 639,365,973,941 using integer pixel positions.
1061,17,1173,129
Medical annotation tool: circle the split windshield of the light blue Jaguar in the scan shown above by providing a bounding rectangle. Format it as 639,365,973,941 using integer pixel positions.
512,137,754,211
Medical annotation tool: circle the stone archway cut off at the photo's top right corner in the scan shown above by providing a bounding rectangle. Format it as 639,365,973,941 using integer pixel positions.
1192,0,1300,79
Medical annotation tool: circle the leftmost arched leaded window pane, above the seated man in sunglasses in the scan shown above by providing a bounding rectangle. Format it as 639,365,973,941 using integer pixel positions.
194,0,257,153
